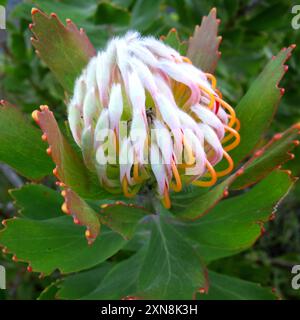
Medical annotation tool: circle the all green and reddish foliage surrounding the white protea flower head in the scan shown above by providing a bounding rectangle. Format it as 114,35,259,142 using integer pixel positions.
0,0,300,299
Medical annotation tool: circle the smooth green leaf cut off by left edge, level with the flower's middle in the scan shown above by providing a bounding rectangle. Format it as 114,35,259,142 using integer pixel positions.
0,100,52,180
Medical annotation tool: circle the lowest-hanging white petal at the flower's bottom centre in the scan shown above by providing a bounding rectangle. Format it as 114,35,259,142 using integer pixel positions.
150,143,168,196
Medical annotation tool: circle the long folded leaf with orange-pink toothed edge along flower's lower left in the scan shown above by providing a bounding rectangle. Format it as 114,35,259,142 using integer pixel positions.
33,106,110,199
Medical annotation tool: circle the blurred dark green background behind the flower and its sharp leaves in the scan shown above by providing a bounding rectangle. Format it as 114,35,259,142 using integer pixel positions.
0,0,300,299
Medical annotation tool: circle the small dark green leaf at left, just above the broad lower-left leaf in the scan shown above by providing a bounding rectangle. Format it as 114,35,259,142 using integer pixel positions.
10,184,63,220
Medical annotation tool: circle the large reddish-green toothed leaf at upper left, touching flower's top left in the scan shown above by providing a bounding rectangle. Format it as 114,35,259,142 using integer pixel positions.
30,8,96,93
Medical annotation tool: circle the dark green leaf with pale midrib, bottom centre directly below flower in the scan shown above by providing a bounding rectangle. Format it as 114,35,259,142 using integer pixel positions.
139,216,207,299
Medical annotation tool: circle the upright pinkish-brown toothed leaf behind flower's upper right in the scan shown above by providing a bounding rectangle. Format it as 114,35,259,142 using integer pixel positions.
187,8,222,73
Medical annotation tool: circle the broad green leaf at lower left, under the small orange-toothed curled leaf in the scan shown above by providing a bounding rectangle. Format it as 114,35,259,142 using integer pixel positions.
0,216,125,275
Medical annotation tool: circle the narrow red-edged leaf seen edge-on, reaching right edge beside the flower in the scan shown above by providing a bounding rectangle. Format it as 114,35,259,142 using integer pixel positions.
172,124,299,220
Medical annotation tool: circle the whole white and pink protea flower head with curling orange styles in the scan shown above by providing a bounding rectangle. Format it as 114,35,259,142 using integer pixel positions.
68,32,240,207
